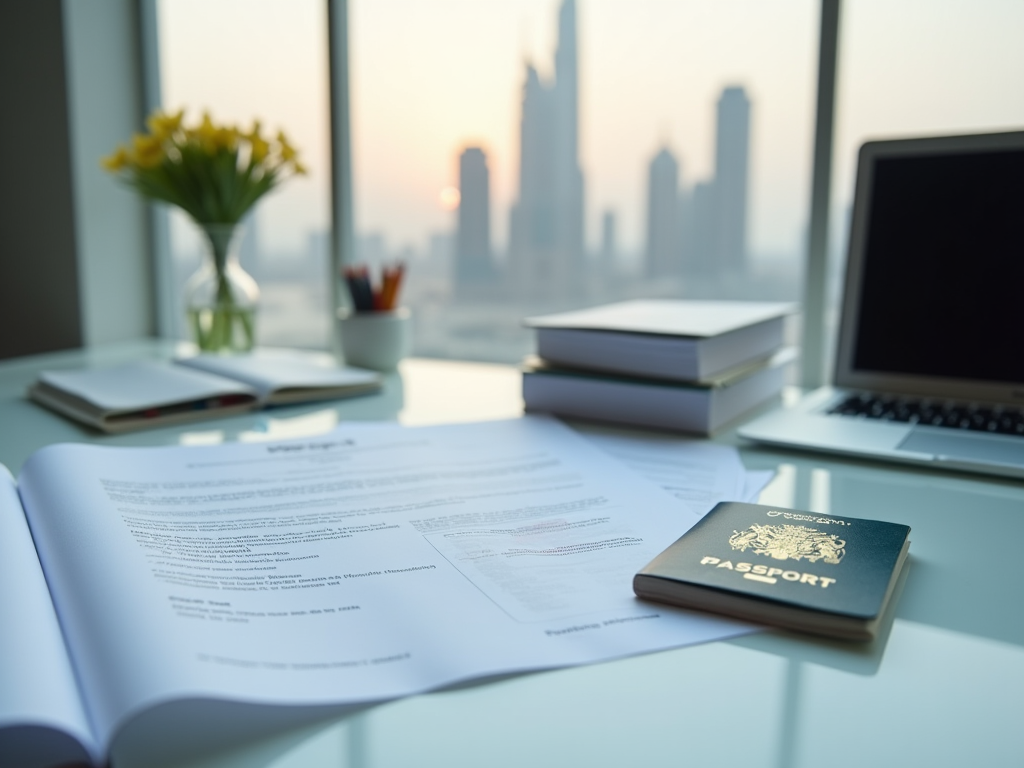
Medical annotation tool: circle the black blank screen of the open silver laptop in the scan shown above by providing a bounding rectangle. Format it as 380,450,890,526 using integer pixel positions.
848,142,1024,384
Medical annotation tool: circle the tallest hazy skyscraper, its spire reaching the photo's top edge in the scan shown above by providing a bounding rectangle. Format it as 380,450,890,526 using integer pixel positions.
509,0,584,297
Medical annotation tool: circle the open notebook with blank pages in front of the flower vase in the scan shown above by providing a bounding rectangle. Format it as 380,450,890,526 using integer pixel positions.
29,349,381,432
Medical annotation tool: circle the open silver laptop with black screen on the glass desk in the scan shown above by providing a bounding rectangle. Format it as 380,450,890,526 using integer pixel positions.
739,131,1024,477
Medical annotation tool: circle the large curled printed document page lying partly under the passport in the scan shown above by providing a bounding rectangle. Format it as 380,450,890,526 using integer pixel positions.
20,417,750,753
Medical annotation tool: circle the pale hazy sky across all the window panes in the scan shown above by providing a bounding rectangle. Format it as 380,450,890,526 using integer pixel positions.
160,0,1024,255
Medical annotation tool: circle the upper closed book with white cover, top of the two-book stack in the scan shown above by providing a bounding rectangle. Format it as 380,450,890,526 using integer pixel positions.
525,299,795,381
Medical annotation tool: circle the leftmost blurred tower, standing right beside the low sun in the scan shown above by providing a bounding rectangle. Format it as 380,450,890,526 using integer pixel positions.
455,146,495,288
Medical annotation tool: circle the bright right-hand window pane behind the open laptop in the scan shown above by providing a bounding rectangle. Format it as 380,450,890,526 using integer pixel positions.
826,0,1024,366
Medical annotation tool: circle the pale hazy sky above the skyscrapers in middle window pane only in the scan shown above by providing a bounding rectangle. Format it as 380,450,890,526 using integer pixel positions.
350,0,816,259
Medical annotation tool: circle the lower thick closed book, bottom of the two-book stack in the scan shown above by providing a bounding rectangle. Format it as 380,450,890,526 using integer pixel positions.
522,347,796,435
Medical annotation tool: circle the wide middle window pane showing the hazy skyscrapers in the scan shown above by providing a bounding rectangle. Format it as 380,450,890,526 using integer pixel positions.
348,0,818,362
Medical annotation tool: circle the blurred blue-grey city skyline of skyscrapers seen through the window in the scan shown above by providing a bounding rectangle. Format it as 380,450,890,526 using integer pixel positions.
453,0,751,299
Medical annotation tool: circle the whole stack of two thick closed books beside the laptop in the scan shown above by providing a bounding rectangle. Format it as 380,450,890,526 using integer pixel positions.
522,299,796,434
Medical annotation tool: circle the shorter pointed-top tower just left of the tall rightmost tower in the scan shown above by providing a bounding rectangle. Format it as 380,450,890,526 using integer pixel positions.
647,147,683,278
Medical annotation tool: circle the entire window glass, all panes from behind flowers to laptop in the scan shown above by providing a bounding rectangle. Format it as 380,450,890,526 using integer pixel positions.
144,0,1024,374
